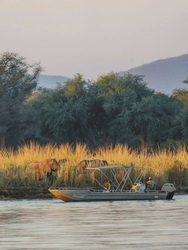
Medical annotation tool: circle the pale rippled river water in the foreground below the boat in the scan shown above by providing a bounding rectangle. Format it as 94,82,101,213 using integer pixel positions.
0,195,188,250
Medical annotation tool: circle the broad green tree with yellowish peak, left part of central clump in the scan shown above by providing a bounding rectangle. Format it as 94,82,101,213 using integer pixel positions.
28,75,93,143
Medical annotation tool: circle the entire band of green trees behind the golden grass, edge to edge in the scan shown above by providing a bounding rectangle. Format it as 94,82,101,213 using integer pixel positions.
0,53,188,147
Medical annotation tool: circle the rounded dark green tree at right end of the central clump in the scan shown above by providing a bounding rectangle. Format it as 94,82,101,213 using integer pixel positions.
133,93,181,146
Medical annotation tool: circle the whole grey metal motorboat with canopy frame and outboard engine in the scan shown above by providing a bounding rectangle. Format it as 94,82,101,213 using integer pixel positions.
49,165,176,202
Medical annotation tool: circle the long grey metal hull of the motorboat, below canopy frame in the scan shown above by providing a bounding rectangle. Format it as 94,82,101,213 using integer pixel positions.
49,188,173,201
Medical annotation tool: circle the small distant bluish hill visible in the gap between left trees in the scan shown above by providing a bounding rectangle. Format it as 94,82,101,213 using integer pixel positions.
38,75,70,89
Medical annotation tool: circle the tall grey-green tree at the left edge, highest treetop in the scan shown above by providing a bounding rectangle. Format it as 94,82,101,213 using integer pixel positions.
0,52,41,147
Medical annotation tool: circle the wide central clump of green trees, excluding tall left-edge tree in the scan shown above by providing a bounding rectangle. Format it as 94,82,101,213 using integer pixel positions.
25,73,187,147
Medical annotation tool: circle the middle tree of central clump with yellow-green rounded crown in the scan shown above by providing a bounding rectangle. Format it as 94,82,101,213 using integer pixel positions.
95,73,154,143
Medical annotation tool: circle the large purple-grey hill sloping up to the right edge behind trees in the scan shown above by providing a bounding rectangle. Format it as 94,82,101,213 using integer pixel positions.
119,54,188,94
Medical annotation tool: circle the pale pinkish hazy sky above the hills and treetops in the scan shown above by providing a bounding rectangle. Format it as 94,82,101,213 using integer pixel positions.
0,0,188,79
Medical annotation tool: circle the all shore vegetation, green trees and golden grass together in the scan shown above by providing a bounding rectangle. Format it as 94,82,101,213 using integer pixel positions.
0,52,188,197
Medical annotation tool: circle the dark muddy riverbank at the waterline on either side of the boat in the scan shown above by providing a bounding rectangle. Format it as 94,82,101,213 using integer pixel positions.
0,187,188,200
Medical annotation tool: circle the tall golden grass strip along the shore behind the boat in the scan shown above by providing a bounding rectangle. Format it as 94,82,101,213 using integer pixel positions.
0,142,188,199
